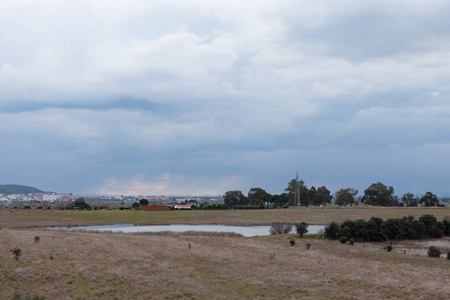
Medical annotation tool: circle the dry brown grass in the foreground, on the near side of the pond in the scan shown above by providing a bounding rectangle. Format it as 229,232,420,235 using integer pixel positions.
0,229,450,299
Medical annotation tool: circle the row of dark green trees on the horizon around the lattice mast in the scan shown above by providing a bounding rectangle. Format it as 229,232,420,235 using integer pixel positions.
223,179,440,208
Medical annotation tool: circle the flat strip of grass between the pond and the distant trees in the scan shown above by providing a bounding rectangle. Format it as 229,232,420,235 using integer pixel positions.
0,208,450,228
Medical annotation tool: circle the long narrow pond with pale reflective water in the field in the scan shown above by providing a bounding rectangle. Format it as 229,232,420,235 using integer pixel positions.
51,224,325,237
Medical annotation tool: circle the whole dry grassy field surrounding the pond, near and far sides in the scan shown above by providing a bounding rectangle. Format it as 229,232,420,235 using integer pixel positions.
0,208,450,299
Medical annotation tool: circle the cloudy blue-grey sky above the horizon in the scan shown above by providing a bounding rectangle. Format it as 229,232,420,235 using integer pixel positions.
0,0,450,197
